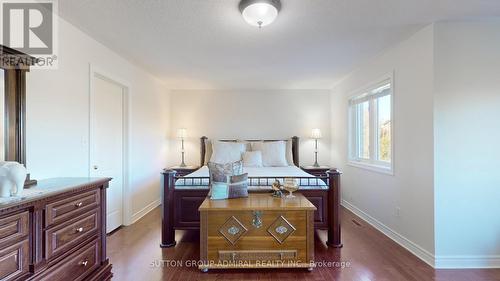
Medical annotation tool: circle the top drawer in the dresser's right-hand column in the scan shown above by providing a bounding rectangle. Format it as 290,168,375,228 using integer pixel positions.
45,190,99,227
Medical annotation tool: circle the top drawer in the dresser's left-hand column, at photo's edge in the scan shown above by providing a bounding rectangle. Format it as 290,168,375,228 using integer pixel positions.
0,211,29,245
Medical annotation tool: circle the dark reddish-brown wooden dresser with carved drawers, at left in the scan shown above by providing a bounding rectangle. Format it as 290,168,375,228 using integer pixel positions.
0,178,112,281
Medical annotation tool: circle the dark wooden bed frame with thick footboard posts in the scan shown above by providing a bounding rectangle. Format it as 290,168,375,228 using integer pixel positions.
160,137,342,248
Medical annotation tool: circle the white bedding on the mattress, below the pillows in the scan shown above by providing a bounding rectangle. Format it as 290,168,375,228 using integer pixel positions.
176,166,328,189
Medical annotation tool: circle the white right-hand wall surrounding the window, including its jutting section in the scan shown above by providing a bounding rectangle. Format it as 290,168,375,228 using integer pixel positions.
331,19,500,268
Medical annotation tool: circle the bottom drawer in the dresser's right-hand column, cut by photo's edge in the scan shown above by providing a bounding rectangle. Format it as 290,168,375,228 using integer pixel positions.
41,239,99,281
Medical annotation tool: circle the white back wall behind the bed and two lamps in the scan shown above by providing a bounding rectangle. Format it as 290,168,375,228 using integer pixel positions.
169,90,330,165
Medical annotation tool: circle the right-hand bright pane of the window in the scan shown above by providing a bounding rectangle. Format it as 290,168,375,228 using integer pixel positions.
377,95,391,162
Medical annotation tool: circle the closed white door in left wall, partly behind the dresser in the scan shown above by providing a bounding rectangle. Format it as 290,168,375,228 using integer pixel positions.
90,74,124,233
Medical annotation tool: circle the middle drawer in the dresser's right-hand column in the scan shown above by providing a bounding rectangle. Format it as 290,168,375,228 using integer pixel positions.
45,210,98,259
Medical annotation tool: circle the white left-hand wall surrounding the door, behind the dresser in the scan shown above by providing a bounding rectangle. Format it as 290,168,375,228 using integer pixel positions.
27,20,169,223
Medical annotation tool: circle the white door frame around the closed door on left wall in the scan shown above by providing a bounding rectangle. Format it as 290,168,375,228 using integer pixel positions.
87,63,132,225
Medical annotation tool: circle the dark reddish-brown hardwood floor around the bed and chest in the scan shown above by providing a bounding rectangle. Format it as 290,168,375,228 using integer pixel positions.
108,208,500,281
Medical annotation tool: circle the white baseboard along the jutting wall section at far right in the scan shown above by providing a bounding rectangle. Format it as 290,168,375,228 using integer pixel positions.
435,256,500,268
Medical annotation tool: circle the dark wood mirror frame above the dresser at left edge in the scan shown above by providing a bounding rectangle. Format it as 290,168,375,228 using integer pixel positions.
0,45,36,186
